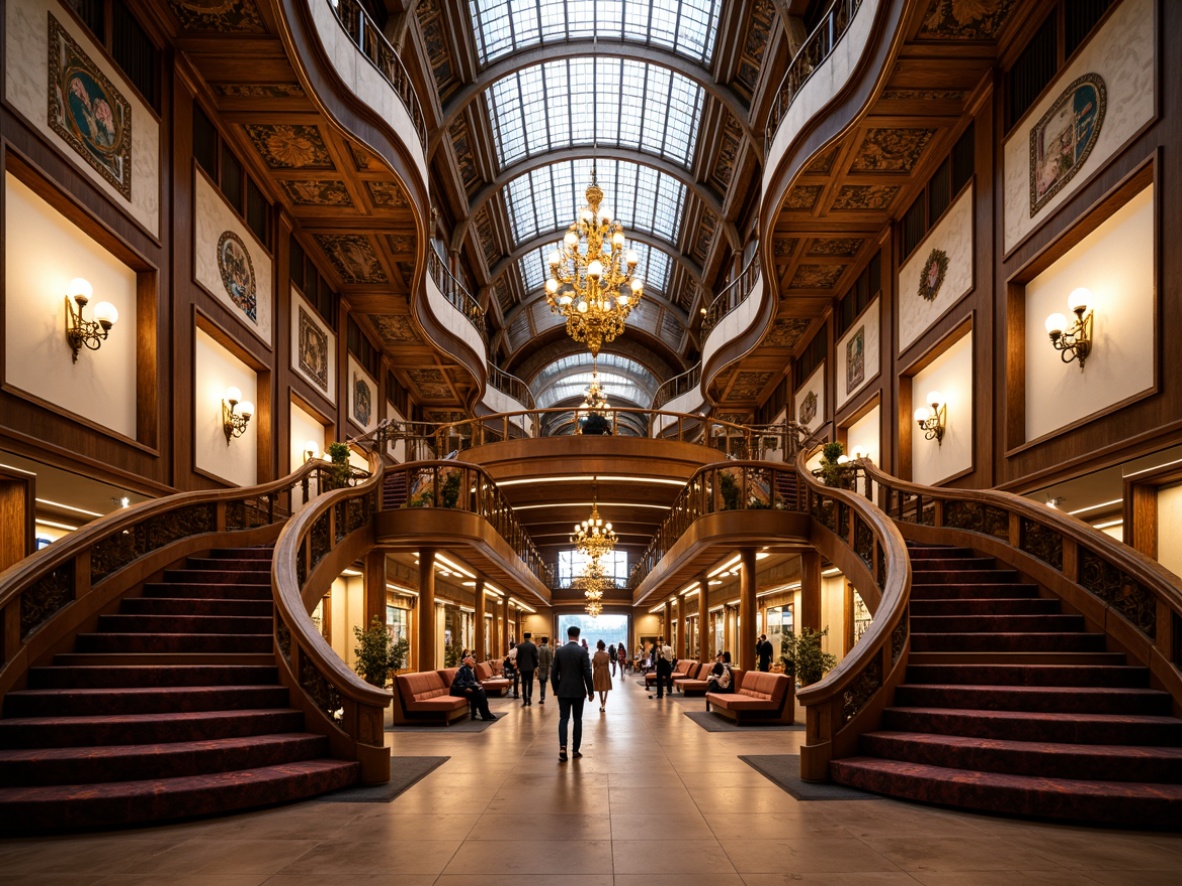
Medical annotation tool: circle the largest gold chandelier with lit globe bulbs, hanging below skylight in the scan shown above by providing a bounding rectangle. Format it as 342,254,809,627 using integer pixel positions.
546,164,644,357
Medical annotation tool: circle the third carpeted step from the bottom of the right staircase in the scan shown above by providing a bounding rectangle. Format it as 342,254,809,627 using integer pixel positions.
882,706,1182,747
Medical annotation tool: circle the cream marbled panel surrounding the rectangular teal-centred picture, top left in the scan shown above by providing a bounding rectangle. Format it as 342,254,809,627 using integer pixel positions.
4,0,160,237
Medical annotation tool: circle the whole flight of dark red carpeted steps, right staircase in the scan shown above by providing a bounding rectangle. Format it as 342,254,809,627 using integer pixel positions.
831,546,1182,827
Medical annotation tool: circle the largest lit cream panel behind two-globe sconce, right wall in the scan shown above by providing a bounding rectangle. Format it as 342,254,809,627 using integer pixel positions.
1026,187,1157,439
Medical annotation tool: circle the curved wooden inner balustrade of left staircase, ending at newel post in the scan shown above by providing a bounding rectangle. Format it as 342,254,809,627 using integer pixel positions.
271,451,391,783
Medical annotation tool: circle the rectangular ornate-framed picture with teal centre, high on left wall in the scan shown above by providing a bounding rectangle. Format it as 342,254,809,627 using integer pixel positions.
48,14,131,200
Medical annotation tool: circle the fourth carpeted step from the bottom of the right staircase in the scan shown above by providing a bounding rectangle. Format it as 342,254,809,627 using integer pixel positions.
895,683,1174,716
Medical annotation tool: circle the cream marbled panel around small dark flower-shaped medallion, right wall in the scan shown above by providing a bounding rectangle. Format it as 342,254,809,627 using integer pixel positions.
898,185,974,353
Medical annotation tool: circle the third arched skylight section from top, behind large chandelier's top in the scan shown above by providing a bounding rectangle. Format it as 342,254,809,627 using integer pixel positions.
506,158,686,248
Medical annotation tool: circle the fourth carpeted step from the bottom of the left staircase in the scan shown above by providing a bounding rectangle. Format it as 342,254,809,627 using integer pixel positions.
4,684,288,717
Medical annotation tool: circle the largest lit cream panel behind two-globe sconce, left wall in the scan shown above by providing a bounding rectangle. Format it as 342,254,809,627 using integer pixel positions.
4,174,136,439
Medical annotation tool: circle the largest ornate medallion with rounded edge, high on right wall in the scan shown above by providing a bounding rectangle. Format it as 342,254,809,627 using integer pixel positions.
1031,73,1108,217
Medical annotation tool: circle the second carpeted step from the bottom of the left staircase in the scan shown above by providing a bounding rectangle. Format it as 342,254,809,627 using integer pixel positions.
0,732,329,787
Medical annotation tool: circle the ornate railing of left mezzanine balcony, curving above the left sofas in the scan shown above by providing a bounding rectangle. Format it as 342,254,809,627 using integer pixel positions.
385,460,554,587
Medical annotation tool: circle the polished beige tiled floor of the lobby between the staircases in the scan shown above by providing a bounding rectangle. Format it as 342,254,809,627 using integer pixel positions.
0,678,1182,886
